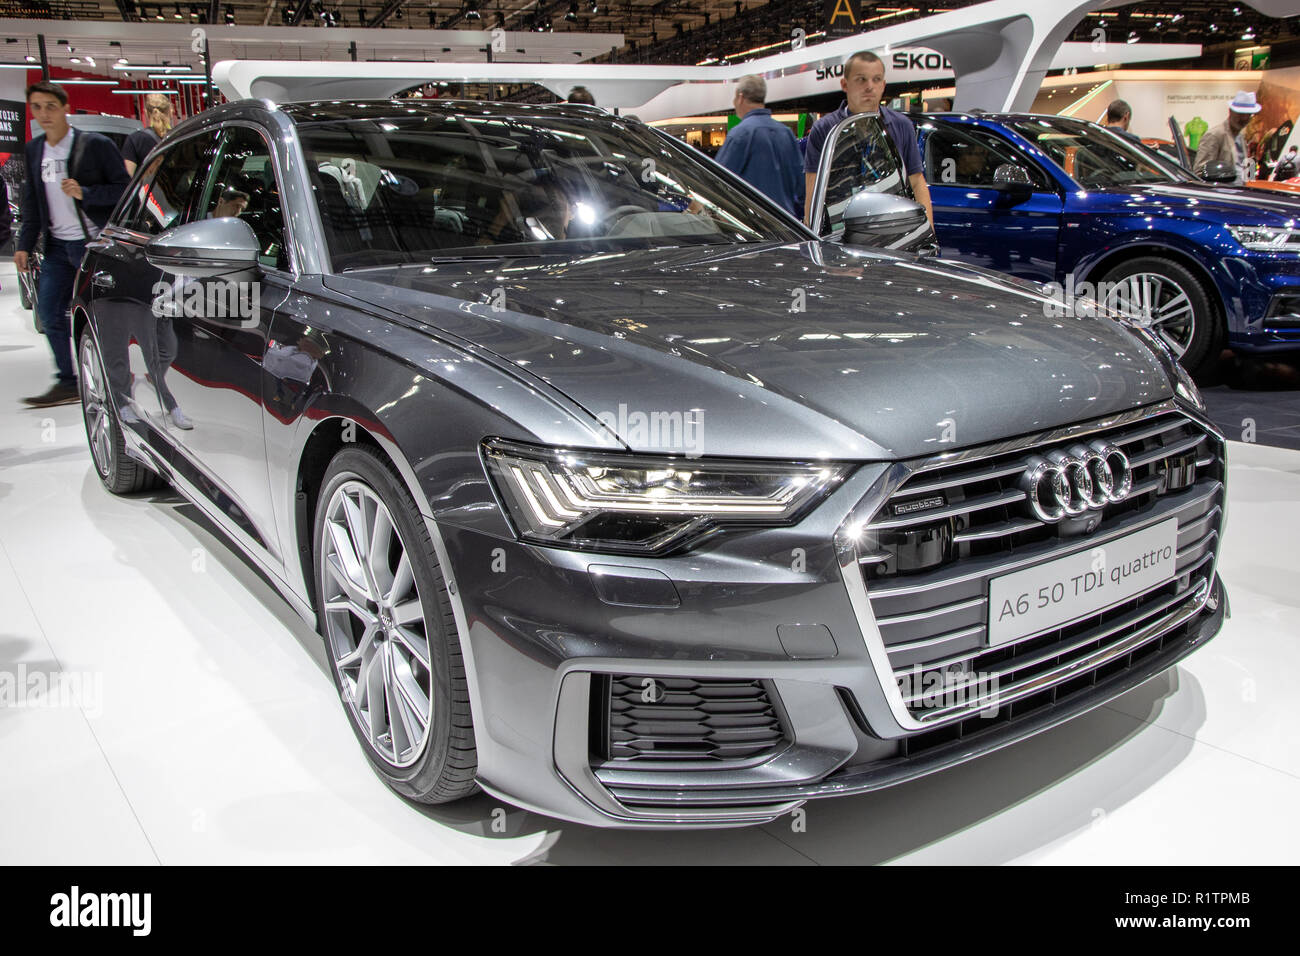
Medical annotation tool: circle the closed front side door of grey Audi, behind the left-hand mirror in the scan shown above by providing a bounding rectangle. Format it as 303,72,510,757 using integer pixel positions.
150,124,293,566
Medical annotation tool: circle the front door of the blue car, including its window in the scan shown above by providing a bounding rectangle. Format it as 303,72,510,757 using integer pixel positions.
920,120,1065,282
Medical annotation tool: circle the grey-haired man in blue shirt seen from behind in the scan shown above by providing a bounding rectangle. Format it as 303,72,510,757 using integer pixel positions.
718,75,803,216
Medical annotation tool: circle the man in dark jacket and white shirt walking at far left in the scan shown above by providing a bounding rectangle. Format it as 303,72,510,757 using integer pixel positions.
13,81,130,408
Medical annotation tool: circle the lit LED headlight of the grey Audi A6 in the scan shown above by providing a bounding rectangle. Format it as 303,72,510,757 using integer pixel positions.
482,438,849,554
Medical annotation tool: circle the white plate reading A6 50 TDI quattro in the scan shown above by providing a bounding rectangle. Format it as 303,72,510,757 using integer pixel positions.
988,518,1178,646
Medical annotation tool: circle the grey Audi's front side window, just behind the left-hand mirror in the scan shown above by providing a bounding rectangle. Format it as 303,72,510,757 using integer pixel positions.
202,126,289,271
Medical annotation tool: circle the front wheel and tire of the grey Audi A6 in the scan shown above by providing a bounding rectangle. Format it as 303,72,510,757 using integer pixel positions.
312,447,477,804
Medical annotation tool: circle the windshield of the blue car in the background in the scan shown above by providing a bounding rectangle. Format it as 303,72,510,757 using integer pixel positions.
1006,116,1184,189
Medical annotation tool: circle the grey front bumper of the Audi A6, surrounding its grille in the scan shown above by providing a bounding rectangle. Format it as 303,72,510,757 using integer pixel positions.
441,403,1226,827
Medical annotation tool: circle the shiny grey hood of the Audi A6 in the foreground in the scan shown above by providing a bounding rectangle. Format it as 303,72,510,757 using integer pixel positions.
325,242,1173,459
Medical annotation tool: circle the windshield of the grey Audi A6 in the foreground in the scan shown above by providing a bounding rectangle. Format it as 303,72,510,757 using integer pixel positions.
300,111,809,271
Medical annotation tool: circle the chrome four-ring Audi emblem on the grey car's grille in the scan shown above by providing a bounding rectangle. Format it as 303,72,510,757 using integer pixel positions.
1021,441,1134,522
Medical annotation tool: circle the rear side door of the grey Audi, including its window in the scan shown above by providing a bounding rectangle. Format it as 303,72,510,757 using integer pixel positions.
85,131,217,434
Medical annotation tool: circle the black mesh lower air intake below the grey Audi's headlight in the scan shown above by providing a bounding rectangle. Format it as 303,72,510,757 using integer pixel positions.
592,674,785,766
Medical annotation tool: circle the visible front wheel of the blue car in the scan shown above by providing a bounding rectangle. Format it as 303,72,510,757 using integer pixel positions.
1101,255,1227,380
